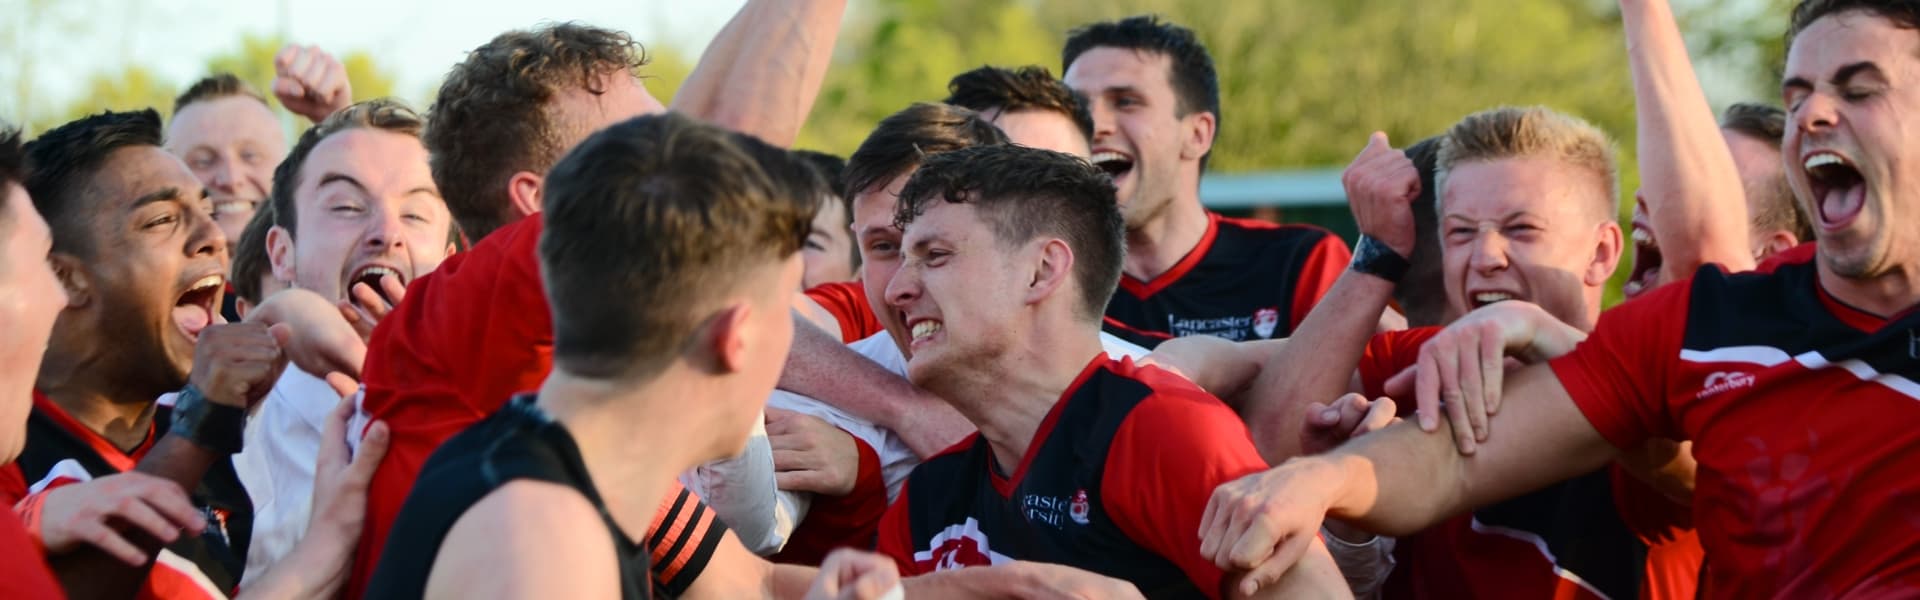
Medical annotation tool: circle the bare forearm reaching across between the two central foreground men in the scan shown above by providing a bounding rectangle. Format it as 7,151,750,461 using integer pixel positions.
780,319,973,458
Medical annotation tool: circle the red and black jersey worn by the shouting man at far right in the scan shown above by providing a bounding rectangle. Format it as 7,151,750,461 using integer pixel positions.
1551,252,1920,598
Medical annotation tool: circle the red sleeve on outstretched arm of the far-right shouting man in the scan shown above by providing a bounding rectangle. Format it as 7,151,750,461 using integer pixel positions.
1549,279,1693,448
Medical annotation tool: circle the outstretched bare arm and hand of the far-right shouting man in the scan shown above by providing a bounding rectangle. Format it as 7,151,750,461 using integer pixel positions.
1200,365,1615,592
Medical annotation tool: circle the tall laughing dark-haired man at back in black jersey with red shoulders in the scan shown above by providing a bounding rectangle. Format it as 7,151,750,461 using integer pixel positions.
1062,15,1352,348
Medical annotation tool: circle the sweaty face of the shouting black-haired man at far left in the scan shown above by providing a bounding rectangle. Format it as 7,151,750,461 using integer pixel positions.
69,146,227,386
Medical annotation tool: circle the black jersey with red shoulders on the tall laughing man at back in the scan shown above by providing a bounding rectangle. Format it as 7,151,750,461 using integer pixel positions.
1106,213,1354,348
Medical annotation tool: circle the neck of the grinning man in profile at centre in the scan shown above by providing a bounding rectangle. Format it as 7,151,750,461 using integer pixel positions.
933,319,1106,475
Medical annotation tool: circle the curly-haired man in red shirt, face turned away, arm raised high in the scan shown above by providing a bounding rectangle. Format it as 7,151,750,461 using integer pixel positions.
348,0,845,598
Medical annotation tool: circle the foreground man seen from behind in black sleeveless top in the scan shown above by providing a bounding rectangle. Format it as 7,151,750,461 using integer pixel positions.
369,113,887,598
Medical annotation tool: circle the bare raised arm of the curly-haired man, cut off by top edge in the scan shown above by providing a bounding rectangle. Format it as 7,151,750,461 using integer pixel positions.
672,0,847,146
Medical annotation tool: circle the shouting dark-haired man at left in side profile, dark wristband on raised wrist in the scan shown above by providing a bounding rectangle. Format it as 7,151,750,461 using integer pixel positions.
0,110,274,598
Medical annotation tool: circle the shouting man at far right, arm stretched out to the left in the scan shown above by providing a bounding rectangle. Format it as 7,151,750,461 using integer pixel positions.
1204,0,1920,598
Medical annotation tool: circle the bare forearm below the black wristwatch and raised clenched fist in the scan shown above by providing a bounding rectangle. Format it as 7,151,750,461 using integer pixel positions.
1244,271,1394,463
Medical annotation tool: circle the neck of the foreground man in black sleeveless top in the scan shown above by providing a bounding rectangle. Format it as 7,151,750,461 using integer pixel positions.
540,369,710,540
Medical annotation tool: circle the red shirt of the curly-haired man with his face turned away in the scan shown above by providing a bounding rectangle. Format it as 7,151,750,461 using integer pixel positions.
346,215,728,598
